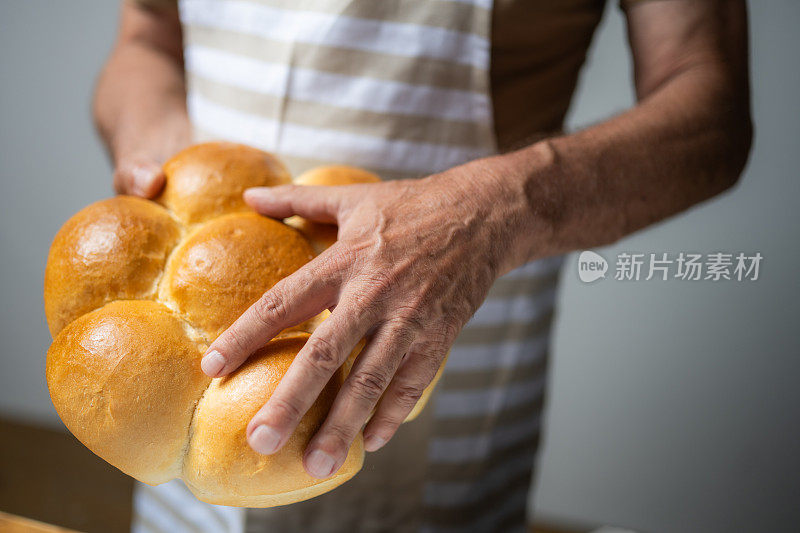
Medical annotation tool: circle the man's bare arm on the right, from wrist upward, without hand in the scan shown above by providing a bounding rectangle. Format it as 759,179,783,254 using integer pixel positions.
484,0,752,272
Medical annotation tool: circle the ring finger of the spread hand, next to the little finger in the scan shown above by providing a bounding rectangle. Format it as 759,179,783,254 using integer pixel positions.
303,322,414,478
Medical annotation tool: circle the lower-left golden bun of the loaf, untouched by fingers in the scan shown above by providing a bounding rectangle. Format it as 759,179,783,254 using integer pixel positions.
47,300,211,485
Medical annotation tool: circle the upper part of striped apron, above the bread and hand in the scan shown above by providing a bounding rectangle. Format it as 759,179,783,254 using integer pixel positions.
181,0,494,178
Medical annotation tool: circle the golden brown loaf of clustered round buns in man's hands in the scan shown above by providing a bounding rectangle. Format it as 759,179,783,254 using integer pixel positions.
44,143,440,507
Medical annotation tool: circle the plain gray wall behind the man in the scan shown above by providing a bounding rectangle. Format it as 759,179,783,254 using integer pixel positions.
0,0,800,532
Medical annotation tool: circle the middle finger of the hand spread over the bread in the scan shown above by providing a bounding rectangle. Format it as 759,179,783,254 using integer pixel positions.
247,302,376,462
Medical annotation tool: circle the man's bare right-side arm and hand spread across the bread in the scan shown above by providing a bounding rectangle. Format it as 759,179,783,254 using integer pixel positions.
202,0,751,477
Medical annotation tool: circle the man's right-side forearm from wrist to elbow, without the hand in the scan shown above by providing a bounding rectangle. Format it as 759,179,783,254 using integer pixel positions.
482,52,751,271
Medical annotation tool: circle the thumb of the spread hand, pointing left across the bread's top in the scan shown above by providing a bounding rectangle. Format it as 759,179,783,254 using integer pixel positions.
244,185,346,224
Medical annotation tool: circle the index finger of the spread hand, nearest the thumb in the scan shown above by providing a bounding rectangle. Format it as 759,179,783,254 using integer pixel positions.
200,256,339,377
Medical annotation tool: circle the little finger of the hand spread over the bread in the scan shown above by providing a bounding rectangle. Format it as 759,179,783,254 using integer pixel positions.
364,342,447,446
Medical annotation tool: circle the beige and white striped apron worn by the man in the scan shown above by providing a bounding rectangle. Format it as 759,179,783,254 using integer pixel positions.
133,0,560,533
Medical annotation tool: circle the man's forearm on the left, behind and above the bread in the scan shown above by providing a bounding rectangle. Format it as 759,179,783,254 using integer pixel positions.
94,4,189,161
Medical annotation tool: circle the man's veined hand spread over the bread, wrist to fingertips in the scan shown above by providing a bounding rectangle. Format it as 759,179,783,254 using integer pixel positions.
202,161,524,478
